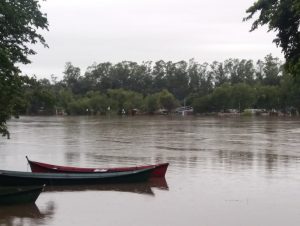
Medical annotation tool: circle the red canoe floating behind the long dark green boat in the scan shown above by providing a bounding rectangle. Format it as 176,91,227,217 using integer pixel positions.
26,156,169,177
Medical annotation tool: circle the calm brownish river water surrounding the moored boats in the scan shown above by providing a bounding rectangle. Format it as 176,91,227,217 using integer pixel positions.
0,116,300,226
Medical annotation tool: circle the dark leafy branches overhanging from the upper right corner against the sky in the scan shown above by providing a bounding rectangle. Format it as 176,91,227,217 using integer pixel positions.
244,0,300,77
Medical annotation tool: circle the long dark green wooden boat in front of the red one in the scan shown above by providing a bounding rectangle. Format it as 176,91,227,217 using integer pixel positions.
0,167,154,186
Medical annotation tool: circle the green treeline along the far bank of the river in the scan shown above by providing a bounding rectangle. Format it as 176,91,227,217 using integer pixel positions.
17,55,300,115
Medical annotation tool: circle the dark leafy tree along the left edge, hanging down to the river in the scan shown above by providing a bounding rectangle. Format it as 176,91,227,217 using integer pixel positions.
0,0,48,137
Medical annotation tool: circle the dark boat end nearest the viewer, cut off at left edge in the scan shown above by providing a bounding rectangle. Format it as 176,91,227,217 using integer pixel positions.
0,186,45,205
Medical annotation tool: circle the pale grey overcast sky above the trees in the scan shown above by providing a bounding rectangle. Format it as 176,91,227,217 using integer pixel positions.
21,0,283,79
